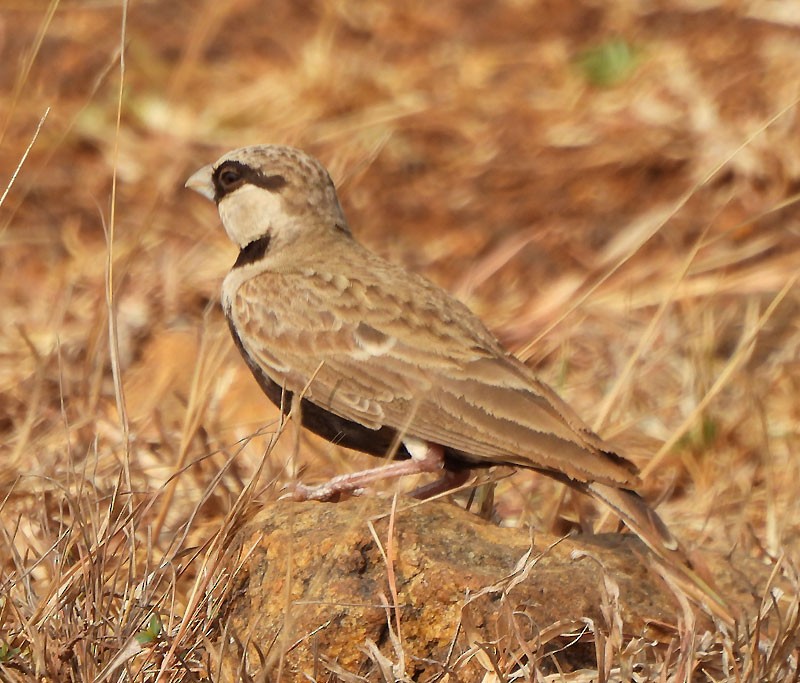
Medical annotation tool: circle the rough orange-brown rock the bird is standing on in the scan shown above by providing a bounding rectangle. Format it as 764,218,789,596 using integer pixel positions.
217,497,720,681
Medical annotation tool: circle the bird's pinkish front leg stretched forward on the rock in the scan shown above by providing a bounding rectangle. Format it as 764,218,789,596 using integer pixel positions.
292,444,444,500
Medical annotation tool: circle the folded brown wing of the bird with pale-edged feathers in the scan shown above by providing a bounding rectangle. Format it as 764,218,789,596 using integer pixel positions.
230,262,638,486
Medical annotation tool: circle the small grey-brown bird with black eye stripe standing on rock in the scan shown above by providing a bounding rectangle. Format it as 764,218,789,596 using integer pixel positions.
186,145,732,620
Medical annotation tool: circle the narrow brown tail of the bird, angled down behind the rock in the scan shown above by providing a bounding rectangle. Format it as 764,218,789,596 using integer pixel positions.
585,482,735,626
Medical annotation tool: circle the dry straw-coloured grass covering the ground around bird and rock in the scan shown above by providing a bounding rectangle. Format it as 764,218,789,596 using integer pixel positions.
0,0,800,681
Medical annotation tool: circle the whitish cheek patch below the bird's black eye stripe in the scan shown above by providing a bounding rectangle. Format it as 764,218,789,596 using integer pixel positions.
218,185,286,247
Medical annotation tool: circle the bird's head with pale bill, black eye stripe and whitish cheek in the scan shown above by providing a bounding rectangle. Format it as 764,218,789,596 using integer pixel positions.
186,145,350,249
